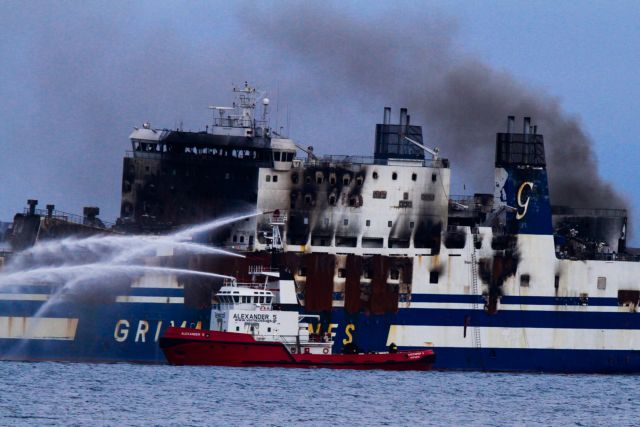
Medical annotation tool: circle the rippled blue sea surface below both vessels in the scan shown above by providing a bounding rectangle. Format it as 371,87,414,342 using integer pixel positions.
0,362,640,426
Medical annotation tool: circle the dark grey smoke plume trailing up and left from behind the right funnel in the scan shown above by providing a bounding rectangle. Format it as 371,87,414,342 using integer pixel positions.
245,3,627,208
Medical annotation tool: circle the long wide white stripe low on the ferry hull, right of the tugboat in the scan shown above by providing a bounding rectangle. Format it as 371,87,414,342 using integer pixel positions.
387,325,640,350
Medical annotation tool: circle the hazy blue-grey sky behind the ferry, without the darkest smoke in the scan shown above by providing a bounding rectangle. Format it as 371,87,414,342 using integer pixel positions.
0,1,640,241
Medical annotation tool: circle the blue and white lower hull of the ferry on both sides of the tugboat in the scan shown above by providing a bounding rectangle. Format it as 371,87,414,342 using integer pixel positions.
0,291,640,373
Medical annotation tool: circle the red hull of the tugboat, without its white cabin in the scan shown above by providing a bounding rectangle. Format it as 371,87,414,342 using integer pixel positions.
160,327,435,371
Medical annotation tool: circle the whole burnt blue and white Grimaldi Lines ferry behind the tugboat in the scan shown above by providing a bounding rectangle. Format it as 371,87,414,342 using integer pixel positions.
0,85,640,372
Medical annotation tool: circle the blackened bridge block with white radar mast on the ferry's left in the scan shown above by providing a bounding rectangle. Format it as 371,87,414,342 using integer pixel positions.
120,84,288,237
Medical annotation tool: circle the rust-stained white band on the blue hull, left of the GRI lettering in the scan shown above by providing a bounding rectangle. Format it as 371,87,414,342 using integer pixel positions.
0,316,78,340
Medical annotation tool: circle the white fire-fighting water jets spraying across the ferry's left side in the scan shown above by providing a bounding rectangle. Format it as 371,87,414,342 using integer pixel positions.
0,212,260,299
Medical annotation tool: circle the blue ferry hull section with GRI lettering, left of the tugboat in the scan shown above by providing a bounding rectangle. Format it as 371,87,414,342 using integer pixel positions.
0,289,210,364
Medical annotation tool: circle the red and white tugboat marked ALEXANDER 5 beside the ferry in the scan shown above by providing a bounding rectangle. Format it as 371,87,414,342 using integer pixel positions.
160,267,435,371
